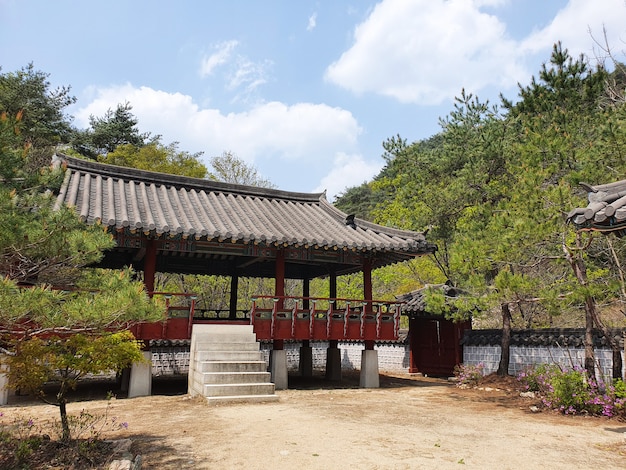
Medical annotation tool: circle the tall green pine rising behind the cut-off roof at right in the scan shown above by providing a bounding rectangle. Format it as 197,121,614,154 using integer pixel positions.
505,43,624,376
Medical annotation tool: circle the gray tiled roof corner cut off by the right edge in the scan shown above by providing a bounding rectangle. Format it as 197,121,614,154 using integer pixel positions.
567,180,626,236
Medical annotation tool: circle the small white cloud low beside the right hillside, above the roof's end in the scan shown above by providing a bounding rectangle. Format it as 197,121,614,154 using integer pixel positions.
313,152,383,202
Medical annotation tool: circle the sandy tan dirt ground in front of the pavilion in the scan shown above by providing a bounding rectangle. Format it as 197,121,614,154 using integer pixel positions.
0,373,626,470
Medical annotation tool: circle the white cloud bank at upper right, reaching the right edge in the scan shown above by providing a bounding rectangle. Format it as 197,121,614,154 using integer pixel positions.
325,0,626,105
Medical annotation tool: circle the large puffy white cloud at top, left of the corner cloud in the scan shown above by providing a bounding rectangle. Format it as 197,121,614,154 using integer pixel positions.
326,0,525,104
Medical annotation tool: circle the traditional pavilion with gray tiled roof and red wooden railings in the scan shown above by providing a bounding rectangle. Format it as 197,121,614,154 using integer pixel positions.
54,155,436,388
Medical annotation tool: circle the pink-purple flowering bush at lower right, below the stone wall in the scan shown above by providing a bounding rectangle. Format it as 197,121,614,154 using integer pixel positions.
517,364,626,417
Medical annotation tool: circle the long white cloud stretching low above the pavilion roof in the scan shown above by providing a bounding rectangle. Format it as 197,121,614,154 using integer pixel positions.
74,84,360,192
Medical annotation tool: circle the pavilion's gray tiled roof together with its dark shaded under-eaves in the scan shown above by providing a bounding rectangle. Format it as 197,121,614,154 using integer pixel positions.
56,155,435,278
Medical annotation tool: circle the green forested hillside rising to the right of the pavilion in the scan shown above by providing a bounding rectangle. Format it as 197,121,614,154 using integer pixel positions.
336,44,626,344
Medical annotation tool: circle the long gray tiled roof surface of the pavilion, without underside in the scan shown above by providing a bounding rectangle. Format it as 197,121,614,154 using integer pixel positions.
57,155,435,259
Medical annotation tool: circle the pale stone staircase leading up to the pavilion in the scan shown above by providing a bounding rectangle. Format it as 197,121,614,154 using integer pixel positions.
188,324,278,403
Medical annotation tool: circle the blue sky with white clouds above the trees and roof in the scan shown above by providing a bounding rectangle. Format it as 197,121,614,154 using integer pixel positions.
0,0,626,202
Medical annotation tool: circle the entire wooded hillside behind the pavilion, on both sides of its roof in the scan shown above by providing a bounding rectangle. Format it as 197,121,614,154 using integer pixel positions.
0,44,626,378
